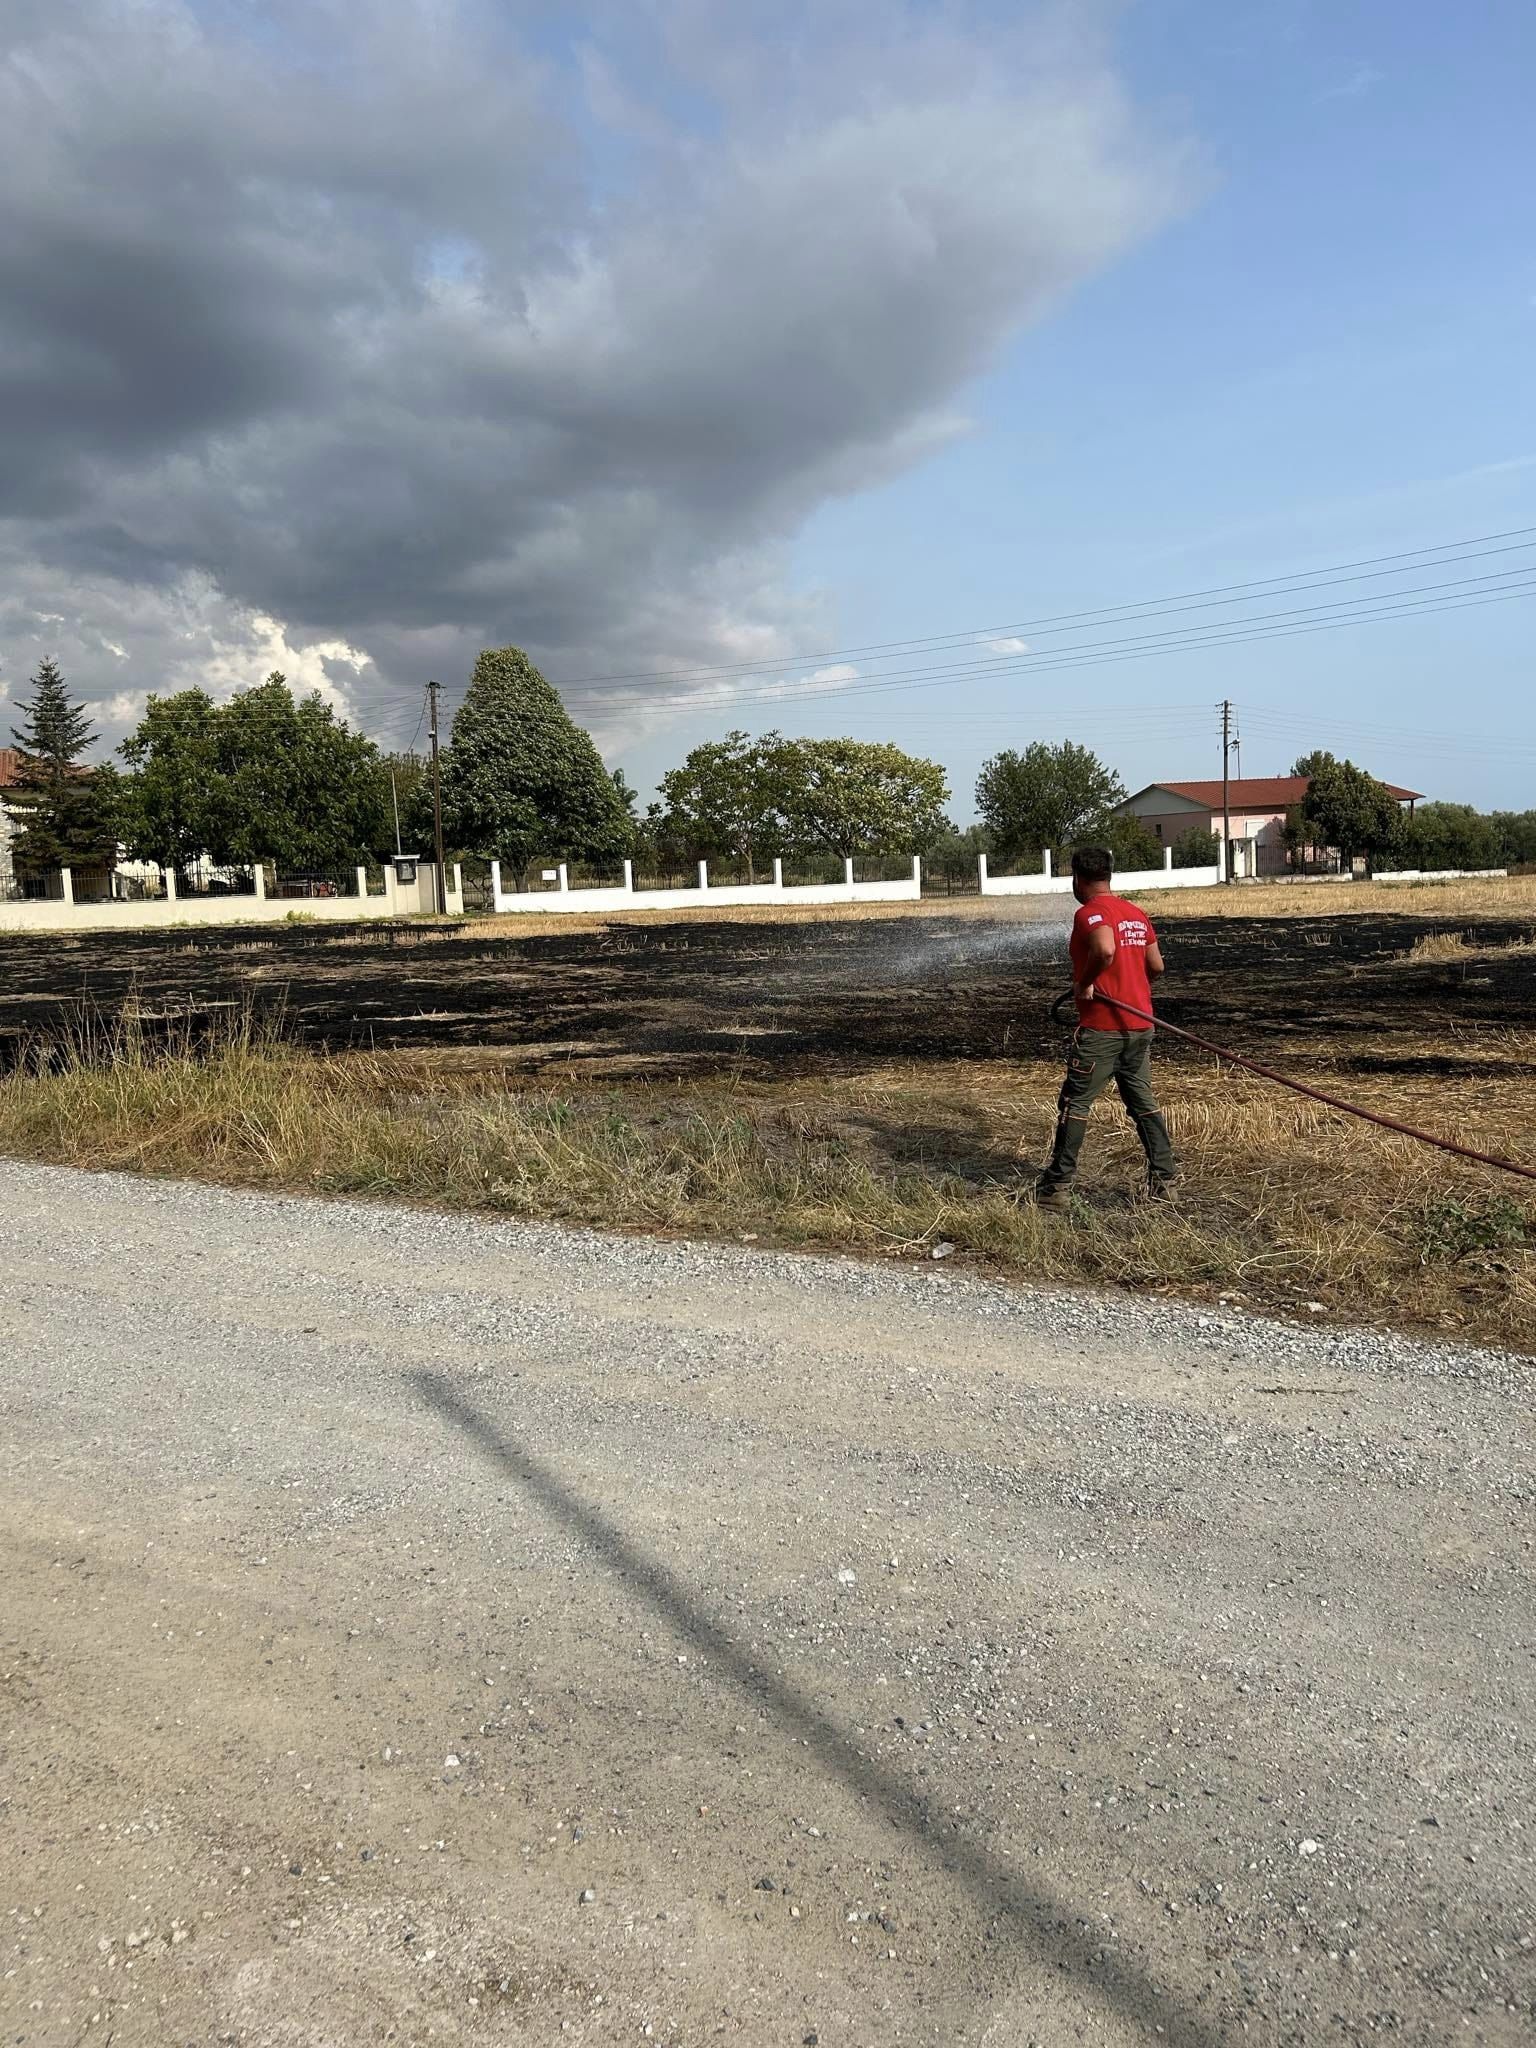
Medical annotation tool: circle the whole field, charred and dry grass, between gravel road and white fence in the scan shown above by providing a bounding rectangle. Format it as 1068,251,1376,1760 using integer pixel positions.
0,879,1536,1350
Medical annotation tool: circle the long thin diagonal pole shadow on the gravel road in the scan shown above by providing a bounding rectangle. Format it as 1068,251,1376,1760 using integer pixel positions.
412,1372,1219,2048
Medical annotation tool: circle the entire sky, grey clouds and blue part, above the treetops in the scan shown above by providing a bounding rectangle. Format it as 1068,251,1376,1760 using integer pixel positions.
0,0,1536,821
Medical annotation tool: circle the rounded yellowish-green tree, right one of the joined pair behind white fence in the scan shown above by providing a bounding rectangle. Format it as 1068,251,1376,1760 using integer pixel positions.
774,739,950,860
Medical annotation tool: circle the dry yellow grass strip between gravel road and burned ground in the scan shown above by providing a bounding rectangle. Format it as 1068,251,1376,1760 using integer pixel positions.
0,1022,1536,1350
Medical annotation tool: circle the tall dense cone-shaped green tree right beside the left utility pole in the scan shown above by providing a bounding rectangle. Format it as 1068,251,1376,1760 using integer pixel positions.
442,647,633,879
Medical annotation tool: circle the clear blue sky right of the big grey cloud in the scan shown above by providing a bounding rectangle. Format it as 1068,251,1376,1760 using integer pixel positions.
635,0,1536,813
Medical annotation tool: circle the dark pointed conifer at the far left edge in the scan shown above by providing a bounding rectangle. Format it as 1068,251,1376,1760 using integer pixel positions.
10,655,119,868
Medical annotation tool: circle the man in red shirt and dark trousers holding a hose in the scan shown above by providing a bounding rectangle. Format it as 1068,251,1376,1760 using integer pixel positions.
1036,846,1180,1210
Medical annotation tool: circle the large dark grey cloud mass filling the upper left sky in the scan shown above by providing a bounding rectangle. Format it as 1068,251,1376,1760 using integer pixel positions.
0,0,1182,753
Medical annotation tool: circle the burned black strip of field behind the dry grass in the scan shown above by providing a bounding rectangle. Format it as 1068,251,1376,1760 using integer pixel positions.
0,905,1536,1083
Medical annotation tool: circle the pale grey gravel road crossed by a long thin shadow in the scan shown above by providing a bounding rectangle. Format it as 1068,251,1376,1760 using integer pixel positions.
0,1165,1536,2048
